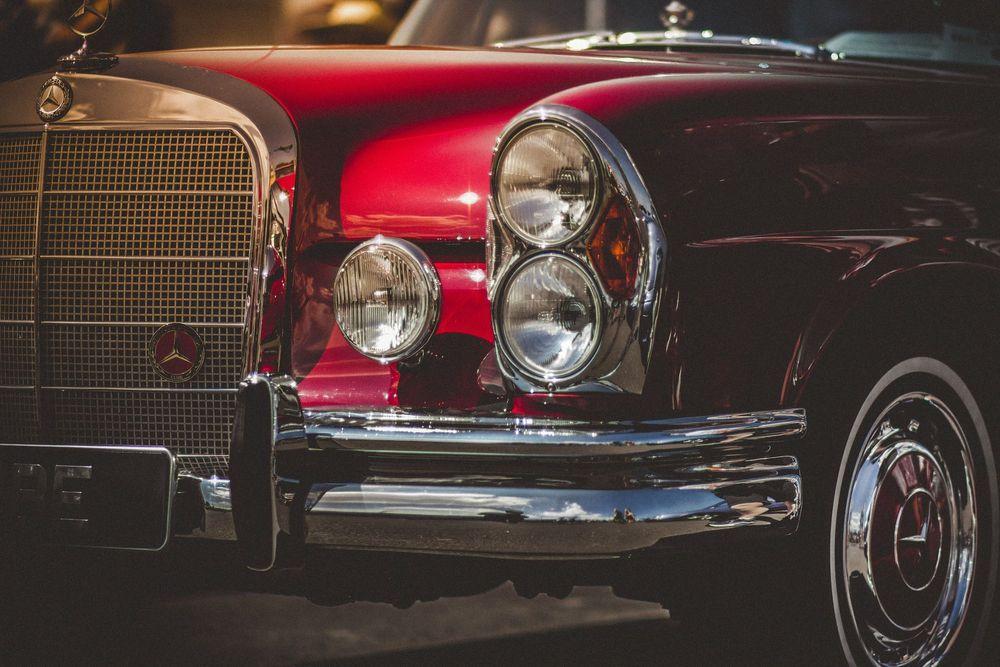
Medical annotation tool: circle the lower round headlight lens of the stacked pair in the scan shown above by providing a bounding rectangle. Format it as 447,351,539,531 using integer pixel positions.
498,253,601,380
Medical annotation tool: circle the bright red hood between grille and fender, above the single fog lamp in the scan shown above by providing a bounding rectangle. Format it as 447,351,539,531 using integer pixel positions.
132,47,856,249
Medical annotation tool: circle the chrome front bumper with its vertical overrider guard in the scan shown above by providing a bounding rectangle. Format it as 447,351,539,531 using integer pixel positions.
227,375,806,570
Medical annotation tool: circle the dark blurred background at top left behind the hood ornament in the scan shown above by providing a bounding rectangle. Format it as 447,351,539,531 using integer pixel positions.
0,0,413,80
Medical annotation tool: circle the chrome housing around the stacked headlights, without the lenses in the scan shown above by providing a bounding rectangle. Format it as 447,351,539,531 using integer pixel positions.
487,105,667,394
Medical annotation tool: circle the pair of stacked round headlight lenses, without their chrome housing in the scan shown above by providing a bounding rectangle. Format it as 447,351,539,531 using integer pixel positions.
494,123,602,381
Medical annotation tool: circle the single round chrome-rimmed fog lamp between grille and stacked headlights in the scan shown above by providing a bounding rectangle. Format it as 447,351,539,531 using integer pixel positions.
333,237,441,362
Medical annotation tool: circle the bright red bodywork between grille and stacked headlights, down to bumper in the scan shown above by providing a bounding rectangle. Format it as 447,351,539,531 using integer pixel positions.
150,49,736,407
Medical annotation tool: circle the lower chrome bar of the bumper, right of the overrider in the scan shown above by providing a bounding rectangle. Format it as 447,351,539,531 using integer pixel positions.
292,472,801,558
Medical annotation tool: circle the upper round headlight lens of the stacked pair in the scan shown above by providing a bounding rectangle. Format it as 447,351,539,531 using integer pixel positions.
495,123,599,246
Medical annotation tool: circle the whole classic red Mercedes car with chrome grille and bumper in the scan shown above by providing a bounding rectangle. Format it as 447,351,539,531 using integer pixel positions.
0,0,1000,665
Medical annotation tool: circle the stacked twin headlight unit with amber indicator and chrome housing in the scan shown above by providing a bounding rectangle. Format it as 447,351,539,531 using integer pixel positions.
487,108,658,391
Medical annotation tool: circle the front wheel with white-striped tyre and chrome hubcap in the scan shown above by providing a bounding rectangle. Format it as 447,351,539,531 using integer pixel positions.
829,357,998,665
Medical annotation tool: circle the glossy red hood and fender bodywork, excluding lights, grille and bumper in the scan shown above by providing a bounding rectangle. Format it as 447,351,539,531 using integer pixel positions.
137,49,1000,417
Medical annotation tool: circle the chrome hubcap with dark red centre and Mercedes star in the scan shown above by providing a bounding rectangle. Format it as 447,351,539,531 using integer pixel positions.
841,393,976,665
